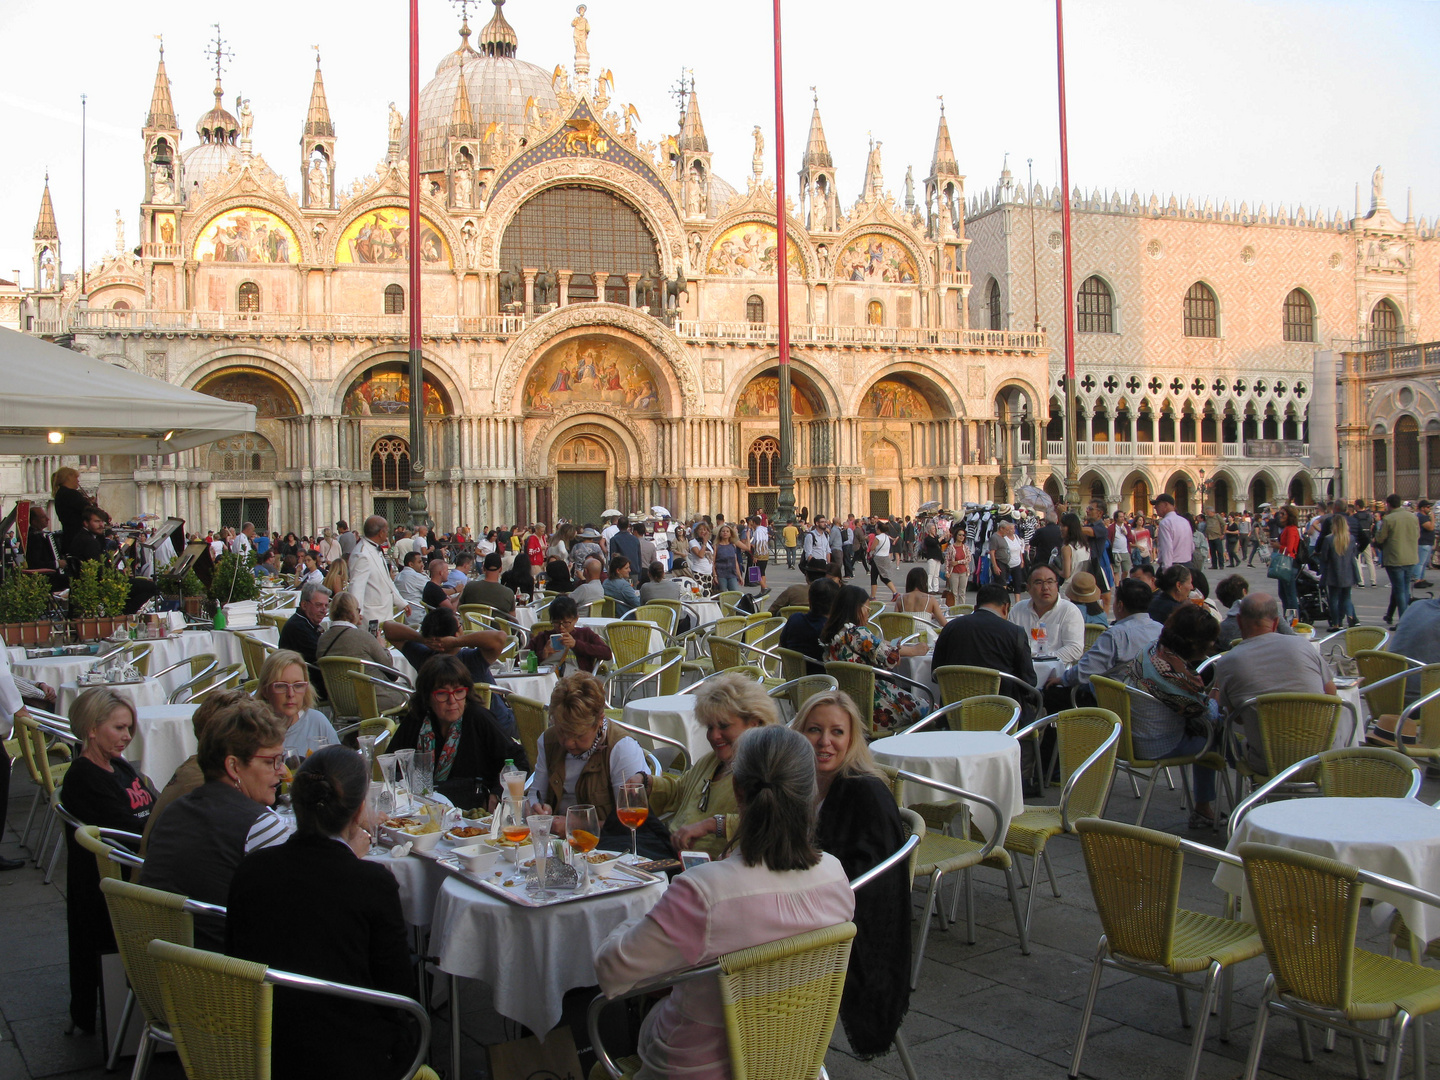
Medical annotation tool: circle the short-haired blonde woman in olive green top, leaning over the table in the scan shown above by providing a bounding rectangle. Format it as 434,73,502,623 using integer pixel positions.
645,675,780,858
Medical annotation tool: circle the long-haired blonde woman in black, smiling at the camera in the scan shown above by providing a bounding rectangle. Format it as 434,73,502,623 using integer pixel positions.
791,690,910,1058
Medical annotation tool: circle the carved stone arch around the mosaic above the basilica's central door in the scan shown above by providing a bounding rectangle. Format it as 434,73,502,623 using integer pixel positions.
492,304,701,416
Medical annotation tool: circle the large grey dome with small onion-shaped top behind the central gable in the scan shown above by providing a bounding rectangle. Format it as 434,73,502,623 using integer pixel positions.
420,0,560,173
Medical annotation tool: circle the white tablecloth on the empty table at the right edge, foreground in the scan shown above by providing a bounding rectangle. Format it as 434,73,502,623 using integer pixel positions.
1214,799,1440,942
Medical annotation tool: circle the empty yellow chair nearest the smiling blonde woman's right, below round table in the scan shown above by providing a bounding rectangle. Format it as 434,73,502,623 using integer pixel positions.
880,765,1030,989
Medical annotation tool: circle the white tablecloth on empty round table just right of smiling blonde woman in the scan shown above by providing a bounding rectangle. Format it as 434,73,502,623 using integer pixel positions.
870,732,1025,837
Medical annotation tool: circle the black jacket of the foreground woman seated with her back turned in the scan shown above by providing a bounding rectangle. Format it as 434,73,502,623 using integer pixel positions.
227,835,415,1080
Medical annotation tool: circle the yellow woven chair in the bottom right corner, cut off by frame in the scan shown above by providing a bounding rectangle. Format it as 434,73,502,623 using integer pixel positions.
1238,844,1440,1080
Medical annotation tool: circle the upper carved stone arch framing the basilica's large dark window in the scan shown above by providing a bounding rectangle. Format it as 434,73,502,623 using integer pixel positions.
477,157,685,278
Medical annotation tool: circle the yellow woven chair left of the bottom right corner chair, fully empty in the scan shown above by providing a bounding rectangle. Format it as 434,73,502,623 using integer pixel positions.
1070,818,1264,1080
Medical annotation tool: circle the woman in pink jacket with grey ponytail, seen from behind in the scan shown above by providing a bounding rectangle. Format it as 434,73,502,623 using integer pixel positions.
595,727,855,1080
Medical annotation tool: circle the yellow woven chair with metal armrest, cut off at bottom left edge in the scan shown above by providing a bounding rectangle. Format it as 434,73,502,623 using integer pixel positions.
147,940,438,1080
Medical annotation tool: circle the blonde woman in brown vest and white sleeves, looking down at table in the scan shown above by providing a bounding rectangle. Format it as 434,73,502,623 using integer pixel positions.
530,671,649,834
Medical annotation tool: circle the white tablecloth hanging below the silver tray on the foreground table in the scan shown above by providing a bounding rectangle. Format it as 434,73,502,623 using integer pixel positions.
426,877,665,1037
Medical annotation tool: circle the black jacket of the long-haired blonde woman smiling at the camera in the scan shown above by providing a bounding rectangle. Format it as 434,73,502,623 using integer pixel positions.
815,776,910,1060
